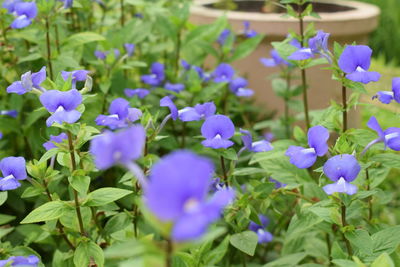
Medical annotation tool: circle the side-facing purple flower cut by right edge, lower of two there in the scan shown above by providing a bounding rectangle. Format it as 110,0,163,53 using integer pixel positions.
363,116,400,153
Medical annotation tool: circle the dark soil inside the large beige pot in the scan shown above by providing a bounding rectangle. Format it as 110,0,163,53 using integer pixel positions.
205,0,353,13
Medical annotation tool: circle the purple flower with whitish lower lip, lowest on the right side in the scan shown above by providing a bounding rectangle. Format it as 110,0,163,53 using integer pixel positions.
323,154,361,195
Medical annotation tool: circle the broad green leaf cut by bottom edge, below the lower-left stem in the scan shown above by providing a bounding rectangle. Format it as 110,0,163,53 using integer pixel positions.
74,241,104,267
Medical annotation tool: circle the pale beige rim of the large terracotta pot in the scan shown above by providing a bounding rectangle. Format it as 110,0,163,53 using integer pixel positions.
191,0,380,22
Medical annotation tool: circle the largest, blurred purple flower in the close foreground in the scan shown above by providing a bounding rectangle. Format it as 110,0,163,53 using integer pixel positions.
144,151,234,241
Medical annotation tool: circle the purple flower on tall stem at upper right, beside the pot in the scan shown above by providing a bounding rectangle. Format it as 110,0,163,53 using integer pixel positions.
338,45,381,84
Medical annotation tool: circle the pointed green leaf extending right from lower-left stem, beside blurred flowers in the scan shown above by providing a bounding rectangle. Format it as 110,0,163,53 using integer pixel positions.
84,187,132,207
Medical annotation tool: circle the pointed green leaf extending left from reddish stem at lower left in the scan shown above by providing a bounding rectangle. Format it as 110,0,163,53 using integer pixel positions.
21,200,68,224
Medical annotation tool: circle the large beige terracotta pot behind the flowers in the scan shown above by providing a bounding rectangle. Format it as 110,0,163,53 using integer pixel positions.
190,0,380,126
